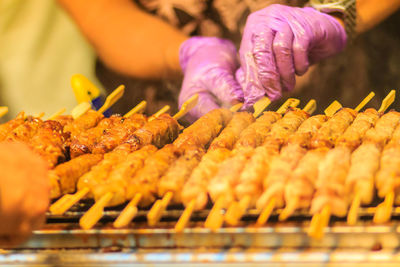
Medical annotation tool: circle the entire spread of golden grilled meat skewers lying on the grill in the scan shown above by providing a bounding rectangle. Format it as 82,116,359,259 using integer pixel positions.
0,75,400,237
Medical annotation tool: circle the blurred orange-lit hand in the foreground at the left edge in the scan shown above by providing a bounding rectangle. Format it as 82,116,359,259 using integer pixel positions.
0,142,50,247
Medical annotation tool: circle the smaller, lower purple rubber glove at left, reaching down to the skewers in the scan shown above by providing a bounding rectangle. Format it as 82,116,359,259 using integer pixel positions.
179,37,243,121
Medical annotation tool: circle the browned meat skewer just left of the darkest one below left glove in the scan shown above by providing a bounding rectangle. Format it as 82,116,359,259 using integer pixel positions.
92,114,147,154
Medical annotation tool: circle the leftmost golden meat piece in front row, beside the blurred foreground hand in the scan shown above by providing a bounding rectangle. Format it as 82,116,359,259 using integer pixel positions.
51,154,103,198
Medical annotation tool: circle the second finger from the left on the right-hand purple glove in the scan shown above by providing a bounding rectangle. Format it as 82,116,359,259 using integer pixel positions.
253,30,282,100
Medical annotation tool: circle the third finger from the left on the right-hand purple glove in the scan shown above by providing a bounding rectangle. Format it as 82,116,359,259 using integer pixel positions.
272,23,296,91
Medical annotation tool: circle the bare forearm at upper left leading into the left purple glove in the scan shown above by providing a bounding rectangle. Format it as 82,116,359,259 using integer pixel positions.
58,0,187,79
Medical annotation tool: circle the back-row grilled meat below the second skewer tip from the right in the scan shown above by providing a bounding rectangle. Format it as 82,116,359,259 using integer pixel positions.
311,108,357,148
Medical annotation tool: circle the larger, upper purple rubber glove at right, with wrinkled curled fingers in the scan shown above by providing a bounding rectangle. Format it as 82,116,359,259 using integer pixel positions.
236,5,347,107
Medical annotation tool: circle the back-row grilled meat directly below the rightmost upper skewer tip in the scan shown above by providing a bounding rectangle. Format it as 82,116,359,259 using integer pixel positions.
336,108,379,150
